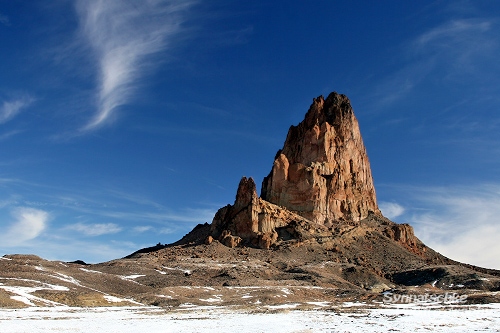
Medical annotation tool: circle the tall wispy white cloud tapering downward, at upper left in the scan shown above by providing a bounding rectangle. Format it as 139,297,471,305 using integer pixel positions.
77,0,194,130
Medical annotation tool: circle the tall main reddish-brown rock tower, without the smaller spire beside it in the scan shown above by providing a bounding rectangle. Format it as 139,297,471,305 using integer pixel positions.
261,92,380,226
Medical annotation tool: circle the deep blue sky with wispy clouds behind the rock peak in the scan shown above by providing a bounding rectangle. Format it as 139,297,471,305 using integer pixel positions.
0,0,500,268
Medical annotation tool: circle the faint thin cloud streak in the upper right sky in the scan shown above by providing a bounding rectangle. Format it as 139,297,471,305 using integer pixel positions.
373,18,500,108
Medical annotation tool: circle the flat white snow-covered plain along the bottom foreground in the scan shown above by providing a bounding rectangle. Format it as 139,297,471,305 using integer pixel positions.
0,304,500,333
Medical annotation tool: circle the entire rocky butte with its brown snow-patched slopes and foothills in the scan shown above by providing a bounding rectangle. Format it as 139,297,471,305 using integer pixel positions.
0,93,500,312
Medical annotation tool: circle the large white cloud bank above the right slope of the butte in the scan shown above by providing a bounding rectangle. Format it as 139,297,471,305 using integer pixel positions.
402,184,500,269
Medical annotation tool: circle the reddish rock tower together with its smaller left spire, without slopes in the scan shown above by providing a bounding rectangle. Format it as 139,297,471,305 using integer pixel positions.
210,92,382,248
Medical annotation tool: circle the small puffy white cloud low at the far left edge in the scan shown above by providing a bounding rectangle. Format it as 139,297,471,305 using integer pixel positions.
0,207,50,247
